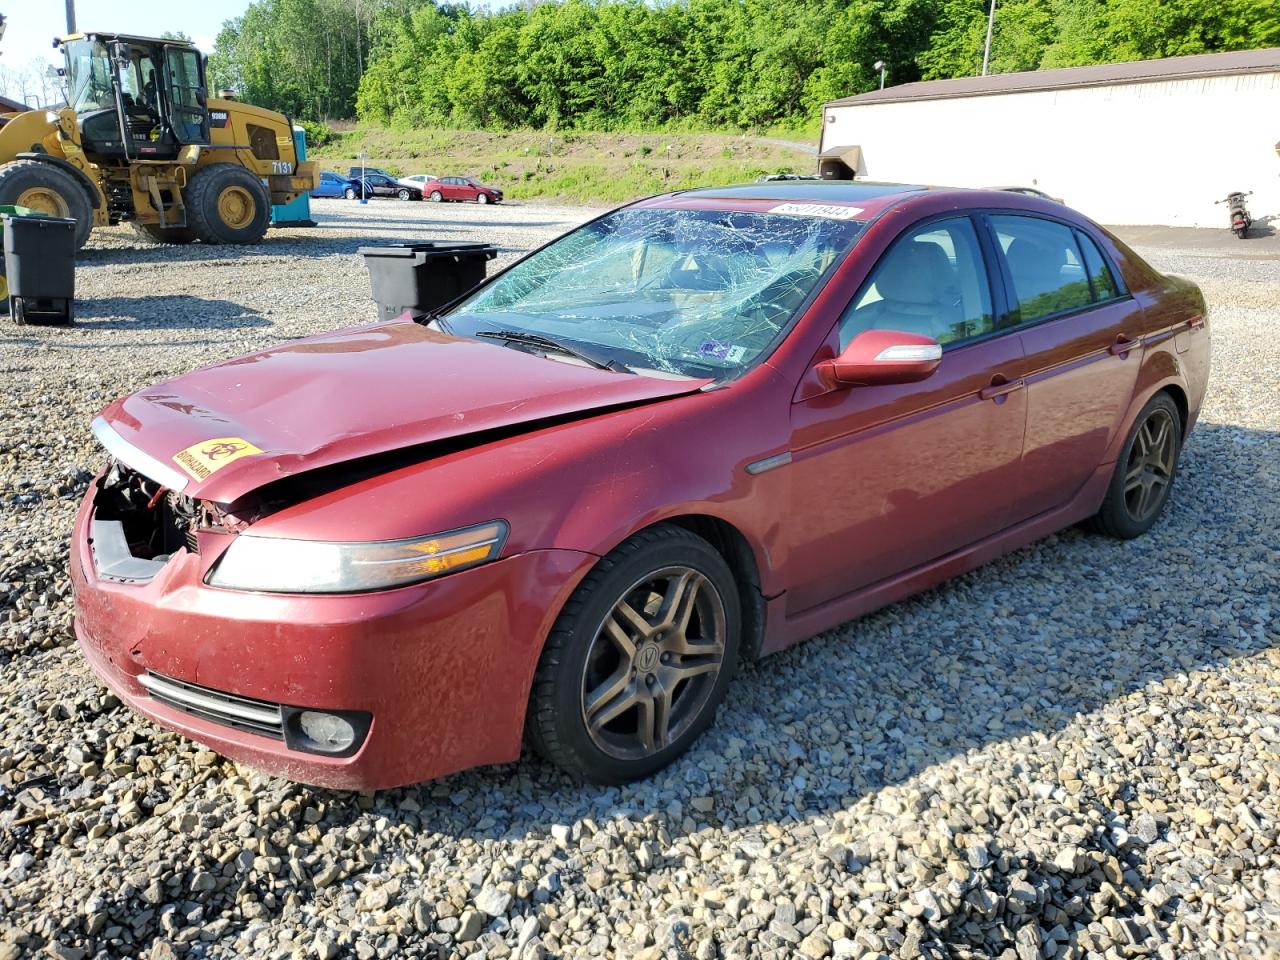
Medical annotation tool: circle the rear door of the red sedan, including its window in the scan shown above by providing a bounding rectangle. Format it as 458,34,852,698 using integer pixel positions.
987,212,1143,522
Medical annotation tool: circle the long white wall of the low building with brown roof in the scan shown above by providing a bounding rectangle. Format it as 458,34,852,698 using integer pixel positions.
822,72,1280,227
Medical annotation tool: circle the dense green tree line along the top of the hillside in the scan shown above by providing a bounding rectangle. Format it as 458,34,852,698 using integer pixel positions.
210,0,1280,131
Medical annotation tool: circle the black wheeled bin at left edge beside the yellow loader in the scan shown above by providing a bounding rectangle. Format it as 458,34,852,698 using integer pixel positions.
4,215,76,324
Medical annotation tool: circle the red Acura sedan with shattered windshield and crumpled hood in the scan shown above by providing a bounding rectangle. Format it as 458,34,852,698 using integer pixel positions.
72,182,1210,788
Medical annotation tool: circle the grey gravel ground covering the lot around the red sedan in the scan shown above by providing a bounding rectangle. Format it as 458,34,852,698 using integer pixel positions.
0,201,1280,960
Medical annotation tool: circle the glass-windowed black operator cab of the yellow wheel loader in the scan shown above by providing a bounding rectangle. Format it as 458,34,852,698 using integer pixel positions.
59,33,209,161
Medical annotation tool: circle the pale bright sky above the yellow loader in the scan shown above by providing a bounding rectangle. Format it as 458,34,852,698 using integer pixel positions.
0,0,250,69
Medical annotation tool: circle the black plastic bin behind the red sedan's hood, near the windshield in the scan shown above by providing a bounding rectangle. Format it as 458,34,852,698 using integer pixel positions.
360,243,498,320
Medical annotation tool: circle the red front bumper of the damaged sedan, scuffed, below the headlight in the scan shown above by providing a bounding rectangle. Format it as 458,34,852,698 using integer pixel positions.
70,488,595,790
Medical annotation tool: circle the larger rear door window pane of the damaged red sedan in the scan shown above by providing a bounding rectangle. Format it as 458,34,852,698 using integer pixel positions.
991,216,1093,324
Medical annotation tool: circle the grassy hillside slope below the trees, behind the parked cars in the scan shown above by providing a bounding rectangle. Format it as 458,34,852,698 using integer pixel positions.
310,124,817,204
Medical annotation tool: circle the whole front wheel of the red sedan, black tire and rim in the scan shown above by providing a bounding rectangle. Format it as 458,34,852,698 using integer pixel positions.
526,525,741,783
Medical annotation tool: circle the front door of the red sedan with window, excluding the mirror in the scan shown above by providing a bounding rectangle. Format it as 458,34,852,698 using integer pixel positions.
787,216,1027,613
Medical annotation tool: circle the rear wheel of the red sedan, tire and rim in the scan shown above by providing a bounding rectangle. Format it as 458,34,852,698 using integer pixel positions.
1089,393,1183,540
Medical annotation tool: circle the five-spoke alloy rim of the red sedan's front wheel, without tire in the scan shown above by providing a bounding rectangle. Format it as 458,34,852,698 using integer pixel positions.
581,566,726,760
